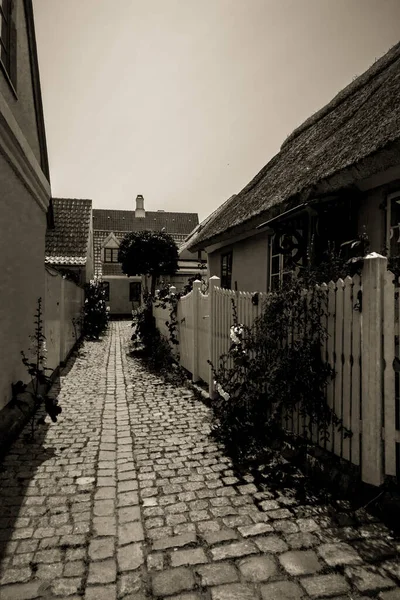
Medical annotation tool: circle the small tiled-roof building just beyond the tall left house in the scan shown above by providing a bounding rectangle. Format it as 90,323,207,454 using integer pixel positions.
45,198,94,284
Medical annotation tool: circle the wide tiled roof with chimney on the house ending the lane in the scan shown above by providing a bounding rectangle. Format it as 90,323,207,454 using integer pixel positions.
93,208,199,236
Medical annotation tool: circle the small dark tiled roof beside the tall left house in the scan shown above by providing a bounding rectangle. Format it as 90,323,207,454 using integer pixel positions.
45,198,92,265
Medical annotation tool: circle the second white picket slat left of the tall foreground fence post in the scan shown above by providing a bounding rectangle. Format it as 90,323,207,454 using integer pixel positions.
342,277,353,460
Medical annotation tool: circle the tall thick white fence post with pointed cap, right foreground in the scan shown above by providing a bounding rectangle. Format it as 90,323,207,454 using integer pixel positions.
361,252,387,486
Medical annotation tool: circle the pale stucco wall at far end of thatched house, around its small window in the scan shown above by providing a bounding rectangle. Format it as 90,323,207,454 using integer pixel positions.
208,233,268,292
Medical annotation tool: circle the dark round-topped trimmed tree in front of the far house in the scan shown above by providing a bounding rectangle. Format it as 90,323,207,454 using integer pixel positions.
118,231,178,296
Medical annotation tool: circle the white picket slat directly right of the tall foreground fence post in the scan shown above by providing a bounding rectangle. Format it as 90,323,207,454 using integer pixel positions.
383,271,396,477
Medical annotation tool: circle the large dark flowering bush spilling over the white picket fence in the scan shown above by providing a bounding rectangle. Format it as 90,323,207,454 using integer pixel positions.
211,255,359,460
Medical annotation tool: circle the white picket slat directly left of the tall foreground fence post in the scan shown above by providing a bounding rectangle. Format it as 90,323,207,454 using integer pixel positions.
350,275,361,466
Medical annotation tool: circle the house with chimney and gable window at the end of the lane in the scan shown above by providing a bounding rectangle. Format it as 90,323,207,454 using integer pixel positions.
93,194,199,316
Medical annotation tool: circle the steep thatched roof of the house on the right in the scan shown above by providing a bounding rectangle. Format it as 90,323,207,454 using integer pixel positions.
190,43,400,250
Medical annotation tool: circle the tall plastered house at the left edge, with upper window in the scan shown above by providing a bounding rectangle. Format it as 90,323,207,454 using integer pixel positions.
0,0,53,412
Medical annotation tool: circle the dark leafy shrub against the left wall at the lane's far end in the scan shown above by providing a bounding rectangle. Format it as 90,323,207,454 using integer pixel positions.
83,278,108,340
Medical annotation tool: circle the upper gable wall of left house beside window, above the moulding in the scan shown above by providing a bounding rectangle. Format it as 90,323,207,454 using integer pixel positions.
0,0,40,164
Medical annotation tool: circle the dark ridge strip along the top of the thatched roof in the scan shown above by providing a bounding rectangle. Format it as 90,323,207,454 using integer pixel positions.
281,42,400,150
